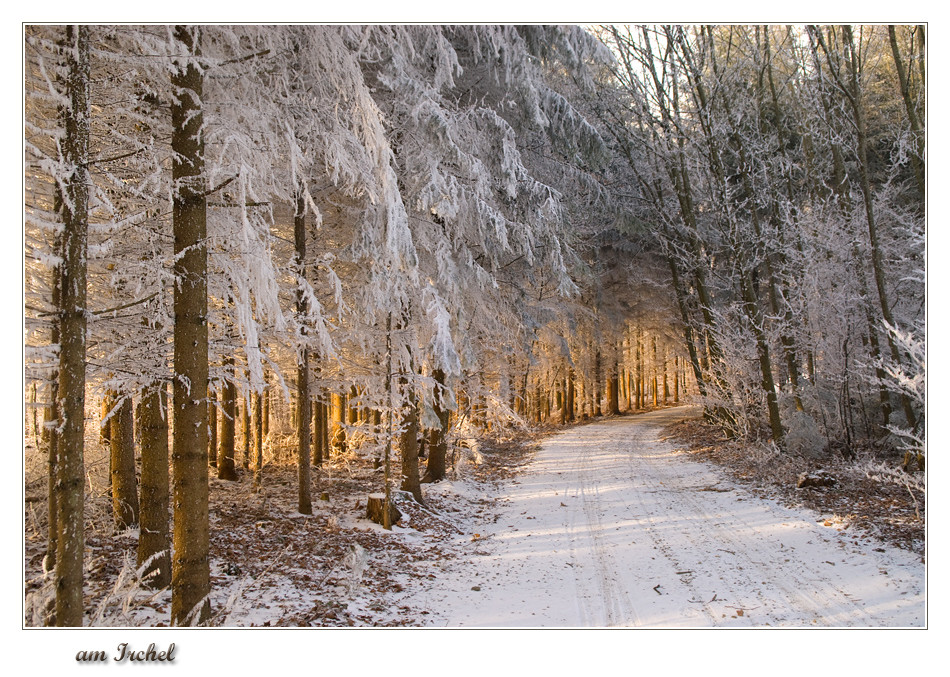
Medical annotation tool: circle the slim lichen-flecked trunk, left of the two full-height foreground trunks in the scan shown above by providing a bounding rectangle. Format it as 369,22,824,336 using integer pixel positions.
55,26,89,626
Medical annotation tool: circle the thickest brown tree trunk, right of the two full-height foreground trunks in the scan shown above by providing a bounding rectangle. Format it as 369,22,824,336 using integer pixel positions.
171,26,211,626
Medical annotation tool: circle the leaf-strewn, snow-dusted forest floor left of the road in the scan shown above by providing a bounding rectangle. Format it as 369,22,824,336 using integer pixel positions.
23,431,535,627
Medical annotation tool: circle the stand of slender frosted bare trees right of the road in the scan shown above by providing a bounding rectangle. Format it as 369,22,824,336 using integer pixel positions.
601,26,922,453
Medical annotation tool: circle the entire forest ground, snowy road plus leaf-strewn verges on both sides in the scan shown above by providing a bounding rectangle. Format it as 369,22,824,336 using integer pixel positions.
24,408,925,627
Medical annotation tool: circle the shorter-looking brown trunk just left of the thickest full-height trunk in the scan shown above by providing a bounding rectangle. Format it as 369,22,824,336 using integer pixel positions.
136,384,172,589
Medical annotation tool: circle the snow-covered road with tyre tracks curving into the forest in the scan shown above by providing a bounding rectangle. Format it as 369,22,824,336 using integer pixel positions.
401,408,925,627
